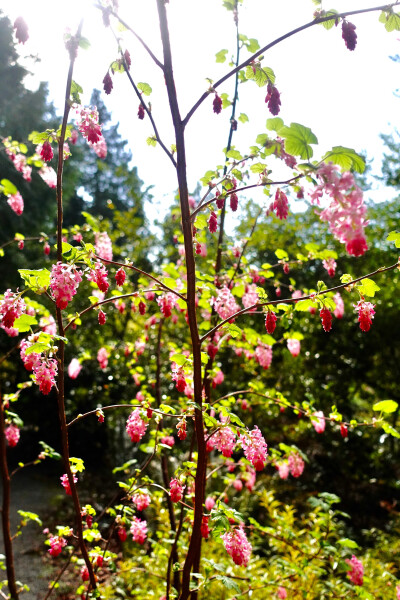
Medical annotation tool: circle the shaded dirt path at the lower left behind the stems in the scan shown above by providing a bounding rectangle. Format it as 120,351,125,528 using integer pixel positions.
0,469,60,600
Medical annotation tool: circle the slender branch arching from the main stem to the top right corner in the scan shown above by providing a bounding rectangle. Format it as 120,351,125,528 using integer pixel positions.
183,2,398,127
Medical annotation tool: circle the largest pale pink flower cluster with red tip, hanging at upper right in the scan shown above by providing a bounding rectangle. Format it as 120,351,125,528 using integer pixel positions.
311,163,368,256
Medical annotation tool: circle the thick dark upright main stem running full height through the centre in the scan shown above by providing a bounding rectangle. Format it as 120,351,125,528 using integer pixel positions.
157,0,207,600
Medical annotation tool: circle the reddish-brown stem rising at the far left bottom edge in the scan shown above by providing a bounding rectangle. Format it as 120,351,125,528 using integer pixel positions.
0,393,18,600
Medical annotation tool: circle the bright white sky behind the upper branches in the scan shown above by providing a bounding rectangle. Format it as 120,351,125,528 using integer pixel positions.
2,0,400,216
